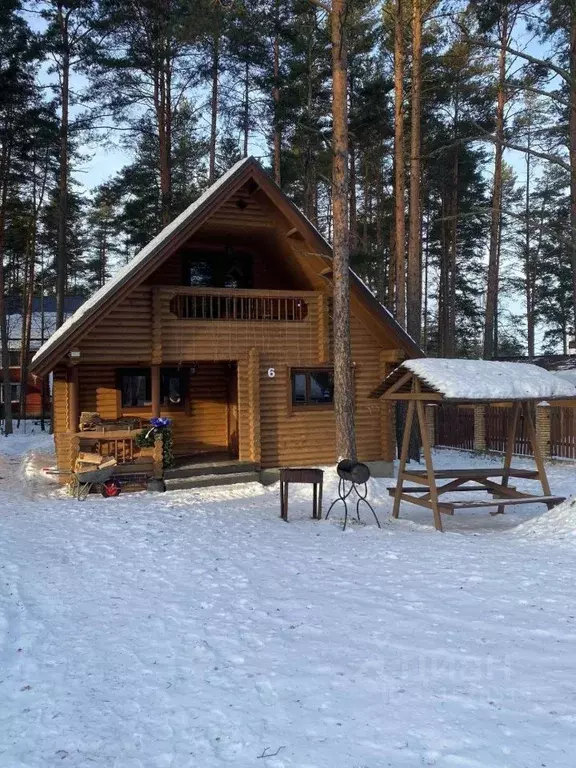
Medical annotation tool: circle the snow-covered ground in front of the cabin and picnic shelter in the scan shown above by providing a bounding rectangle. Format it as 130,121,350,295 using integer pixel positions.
0,435,576,768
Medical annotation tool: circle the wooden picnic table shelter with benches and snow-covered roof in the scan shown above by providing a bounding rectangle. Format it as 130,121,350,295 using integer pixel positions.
371,358,576,531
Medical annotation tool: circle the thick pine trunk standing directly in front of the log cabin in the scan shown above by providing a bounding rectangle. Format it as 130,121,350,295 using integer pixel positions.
331,0,356,459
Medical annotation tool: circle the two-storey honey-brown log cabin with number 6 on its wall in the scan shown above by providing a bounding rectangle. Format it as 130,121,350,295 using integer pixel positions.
32,158,423,480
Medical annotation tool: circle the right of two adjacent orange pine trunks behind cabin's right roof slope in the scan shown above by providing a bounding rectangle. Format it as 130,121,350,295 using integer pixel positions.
406,0,423,344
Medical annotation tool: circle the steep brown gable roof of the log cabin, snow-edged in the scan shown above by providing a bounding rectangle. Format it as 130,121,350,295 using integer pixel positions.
31,157,423,374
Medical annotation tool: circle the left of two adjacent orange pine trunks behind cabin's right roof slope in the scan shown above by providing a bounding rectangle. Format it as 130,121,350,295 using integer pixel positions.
388,0,406,327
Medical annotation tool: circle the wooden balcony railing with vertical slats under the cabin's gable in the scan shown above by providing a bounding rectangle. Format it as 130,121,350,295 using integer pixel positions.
170,289,312,323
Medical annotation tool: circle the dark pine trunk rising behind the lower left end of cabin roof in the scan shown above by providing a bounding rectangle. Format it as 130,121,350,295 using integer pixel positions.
56,2,70,328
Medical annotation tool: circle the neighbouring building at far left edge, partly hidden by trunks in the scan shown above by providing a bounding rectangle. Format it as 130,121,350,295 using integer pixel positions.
0,296,86,418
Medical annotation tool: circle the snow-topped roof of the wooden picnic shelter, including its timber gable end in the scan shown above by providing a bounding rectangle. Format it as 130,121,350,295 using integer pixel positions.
370,357,576,403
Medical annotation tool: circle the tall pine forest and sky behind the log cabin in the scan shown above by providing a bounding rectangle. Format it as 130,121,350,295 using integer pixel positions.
0,0,576,376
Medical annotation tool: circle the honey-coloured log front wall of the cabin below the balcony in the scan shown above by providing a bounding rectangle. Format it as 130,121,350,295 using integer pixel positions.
55,286,394,467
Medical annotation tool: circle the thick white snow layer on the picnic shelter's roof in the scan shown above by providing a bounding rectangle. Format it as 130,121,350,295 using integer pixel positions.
401,357,576,401
